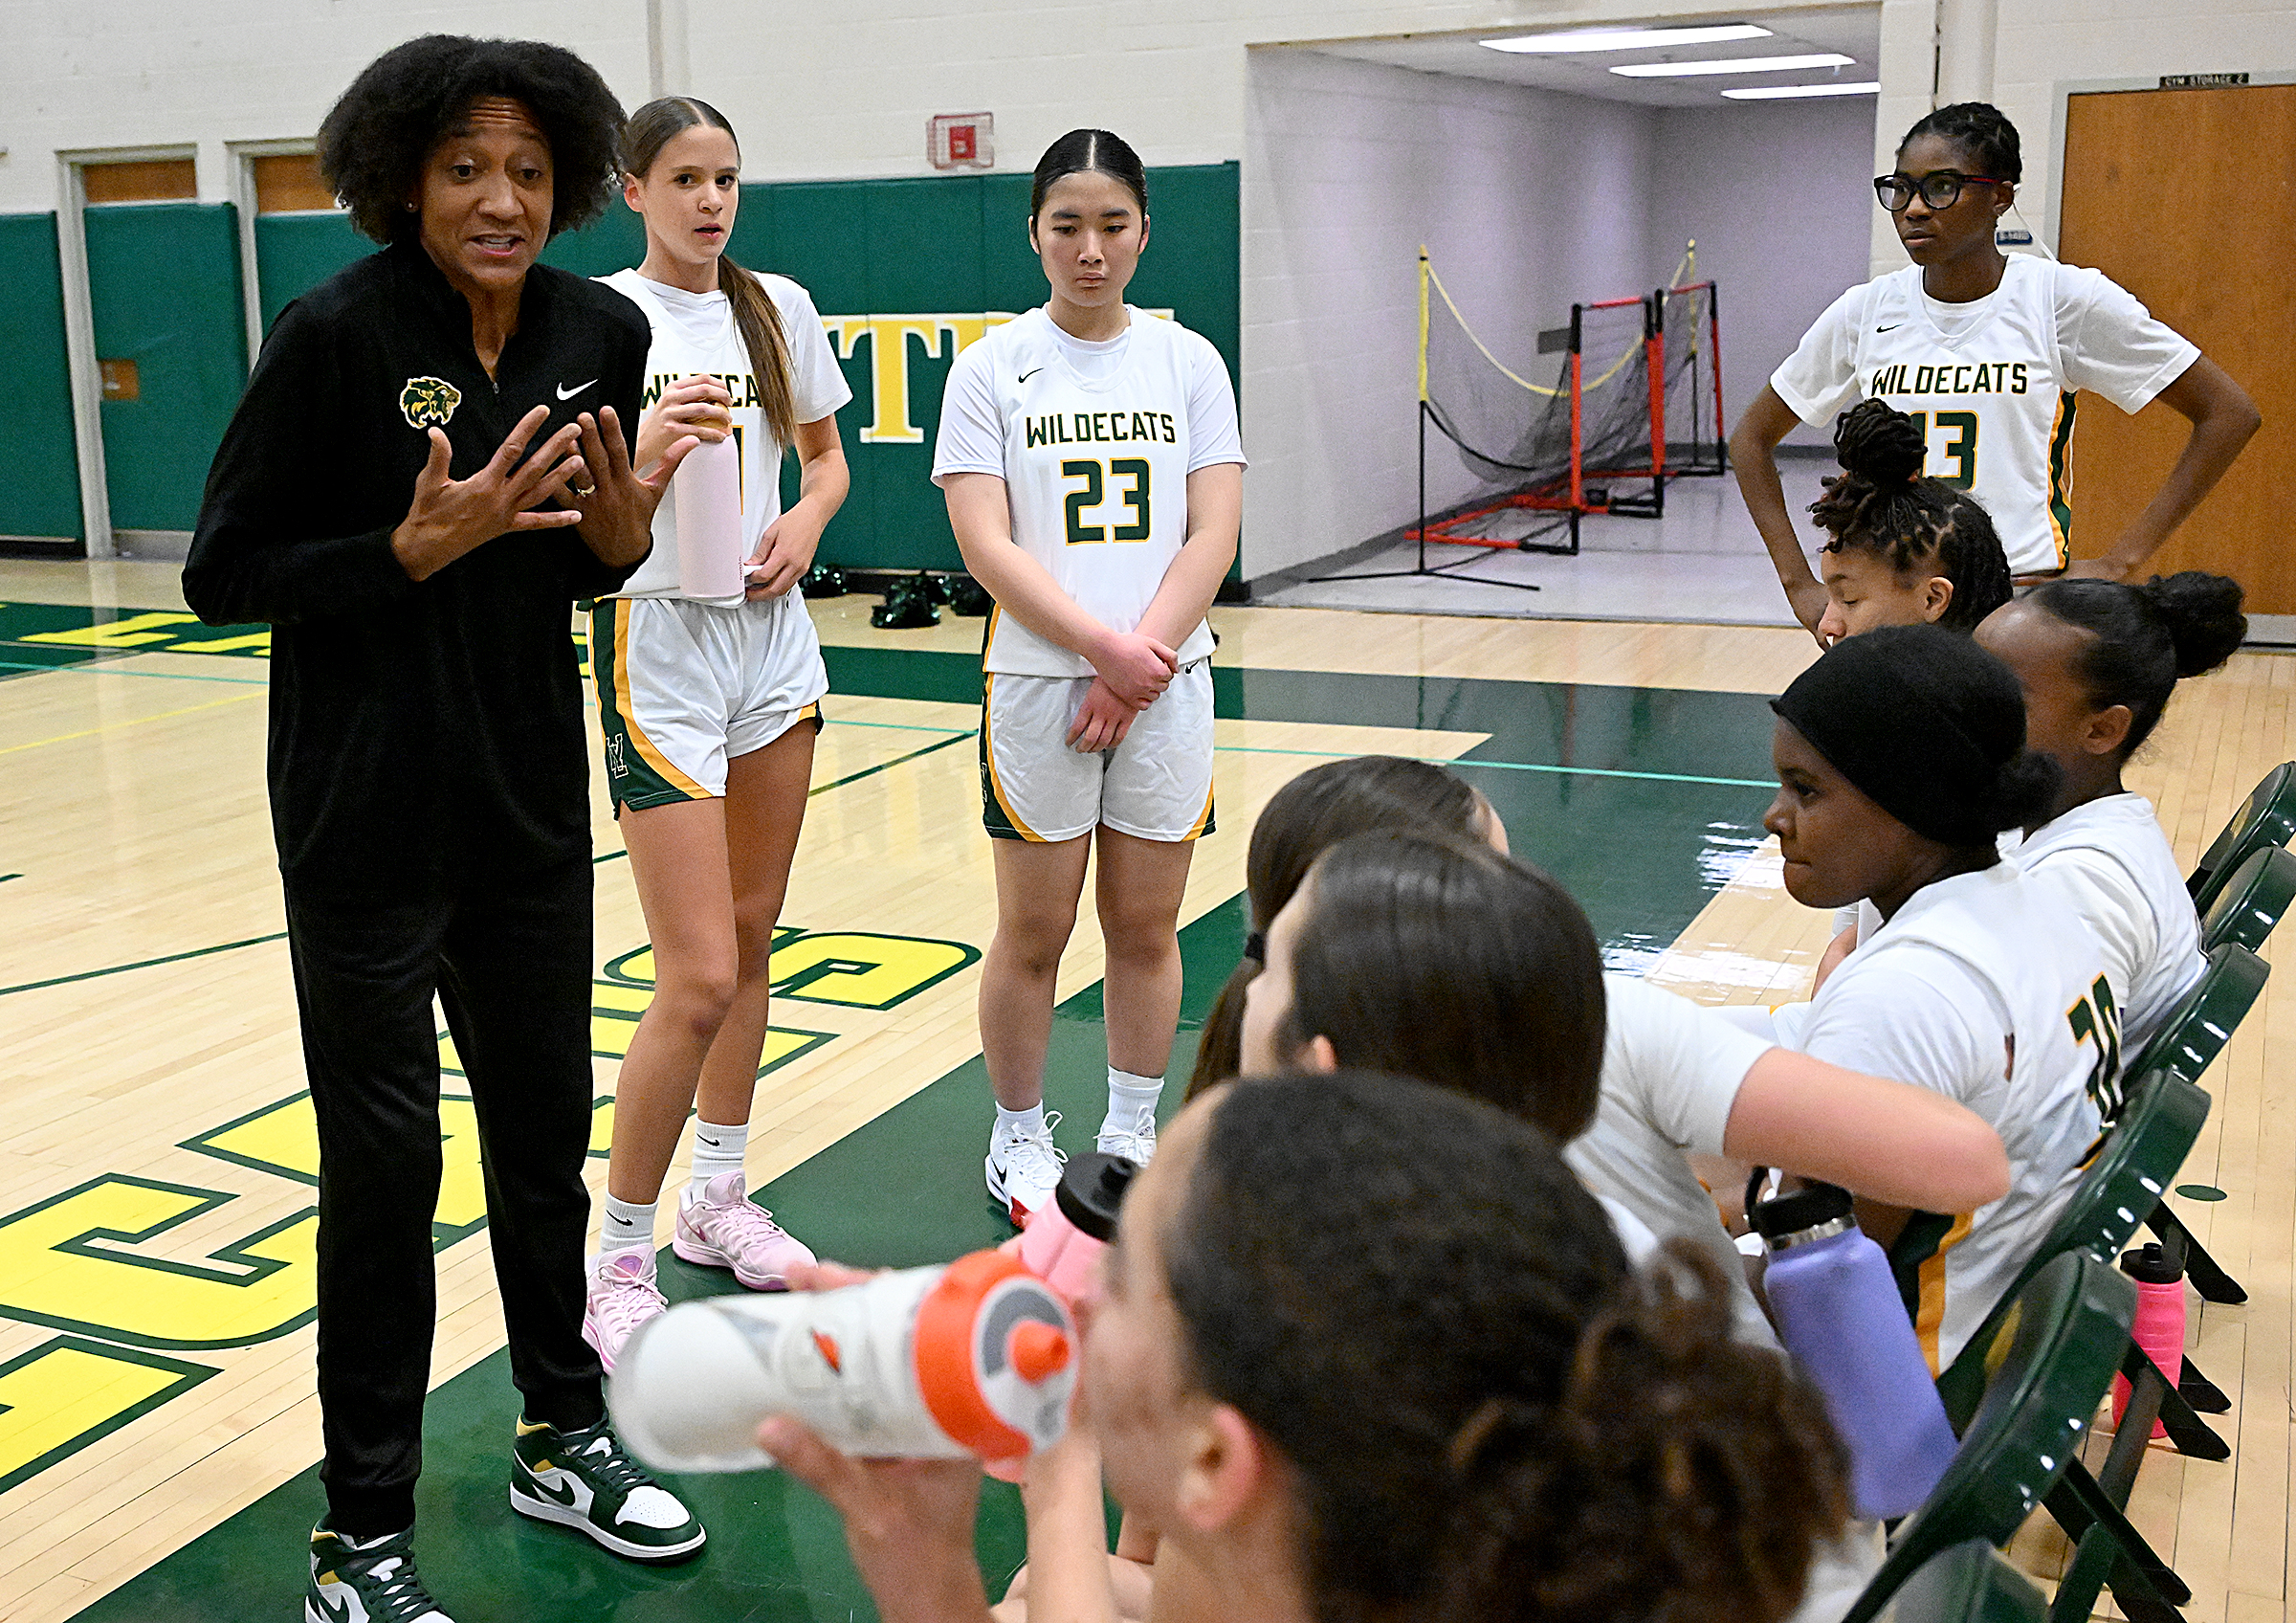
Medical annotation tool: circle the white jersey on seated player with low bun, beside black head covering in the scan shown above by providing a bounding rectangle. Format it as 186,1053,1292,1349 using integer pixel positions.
2011,794,2206,1058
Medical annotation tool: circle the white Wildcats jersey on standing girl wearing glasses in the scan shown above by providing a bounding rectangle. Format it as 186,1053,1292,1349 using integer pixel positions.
1770,255,2199,574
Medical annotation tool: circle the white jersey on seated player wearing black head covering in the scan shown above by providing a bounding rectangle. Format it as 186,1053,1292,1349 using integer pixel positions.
1777,863,2122,1370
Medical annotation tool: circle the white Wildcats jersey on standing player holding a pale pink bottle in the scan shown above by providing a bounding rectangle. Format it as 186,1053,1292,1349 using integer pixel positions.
597,269,854,606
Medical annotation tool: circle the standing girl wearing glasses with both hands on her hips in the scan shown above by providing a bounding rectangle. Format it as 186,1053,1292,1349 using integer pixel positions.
1729,101,2260,632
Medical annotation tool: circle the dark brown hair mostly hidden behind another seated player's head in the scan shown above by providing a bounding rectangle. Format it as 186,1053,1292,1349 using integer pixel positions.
1187,755,1483,1100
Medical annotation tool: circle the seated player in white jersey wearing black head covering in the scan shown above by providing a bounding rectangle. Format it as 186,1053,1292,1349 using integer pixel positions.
1763,627,2119,1368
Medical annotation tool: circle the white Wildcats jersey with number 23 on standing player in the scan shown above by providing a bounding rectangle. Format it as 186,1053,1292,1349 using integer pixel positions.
932,307,1245,678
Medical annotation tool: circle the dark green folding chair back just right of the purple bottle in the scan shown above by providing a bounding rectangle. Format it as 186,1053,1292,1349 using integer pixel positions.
1842,1251,2130,1623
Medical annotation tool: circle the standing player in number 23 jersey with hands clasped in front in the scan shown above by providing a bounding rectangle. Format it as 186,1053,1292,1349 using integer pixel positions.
932,128,1245,1221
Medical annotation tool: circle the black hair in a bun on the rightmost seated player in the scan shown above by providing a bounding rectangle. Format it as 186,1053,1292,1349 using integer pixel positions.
2027,569,2248,760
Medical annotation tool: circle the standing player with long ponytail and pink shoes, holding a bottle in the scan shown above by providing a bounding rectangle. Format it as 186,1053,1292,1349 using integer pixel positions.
584,97,851,1370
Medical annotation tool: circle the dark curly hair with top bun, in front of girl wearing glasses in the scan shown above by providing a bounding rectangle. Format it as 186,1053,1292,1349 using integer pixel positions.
1809,399,2011,632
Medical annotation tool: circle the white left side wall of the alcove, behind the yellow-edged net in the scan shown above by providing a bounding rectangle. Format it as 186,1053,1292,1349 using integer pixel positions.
1245,48,1655,579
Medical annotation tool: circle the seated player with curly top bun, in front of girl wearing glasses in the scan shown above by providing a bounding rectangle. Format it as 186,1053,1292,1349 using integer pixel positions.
1809,399,2009,645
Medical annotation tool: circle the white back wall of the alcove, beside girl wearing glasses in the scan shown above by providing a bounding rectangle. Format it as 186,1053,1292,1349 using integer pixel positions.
1651,97,1876,445
